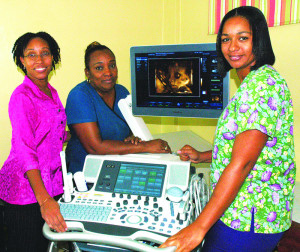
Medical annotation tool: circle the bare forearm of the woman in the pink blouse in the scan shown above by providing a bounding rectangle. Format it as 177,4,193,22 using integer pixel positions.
26,169,51,206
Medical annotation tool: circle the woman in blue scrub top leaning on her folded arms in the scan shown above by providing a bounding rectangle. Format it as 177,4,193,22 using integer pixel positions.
66,42,171,173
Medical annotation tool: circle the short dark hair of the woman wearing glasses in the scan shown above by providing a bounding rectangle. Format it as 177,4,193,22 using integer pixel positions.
12,31,60,74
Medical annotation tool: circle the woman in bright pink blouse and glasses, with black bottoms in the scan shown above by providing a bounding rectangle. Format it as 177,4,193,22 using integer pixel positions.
0,32,68,252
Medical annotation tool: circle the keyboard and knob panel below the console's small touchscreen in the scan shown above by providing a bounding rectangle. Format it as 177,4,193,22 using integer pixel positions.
59,194,192,236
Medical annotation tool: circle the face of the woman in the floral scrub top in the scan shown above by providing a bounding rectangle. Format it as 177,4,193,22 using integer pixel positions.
221,16,255,77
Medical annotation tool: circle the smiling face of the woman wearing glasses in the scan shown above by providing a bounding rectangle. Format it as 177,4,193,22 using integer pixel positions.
20,37,53,84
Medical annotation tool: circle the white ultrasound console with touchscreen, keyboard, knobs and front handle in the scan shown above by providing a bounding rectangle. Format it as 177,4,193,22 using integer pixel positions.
43,154,193,251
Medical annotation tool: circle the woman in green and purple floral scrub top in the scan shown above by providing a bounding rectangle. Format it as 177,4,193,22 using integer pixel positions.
161,6,296,252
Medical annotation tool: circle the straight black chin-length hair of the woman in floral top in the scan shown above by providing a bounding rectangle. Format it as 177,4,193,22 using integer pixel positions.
216,6,275,77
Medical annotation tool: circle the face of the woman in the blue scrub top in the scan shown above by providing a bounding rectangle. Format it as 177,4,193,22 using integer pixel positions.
85,49,118,94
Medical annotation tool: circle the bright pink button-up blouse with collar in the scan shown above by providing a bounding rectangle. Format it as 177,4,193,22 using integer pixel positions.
0,76,67,205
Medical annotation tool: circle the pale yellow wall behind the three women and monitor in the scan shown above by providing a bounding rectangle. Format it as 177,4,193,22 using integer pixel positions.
0,0,300,181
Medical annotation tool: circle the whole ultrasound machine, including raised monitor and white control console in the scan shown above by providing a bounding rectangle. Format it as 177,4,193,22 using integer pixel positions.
43,43,225,251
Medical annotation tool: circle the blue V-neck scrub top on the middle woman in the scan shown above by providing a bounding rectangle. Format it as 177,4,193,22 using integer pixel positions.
66,81,131,173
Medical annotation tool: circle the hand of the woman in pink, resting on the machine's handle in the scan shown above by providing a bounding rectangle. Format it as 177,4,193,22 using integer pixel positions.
40,197,67,232
